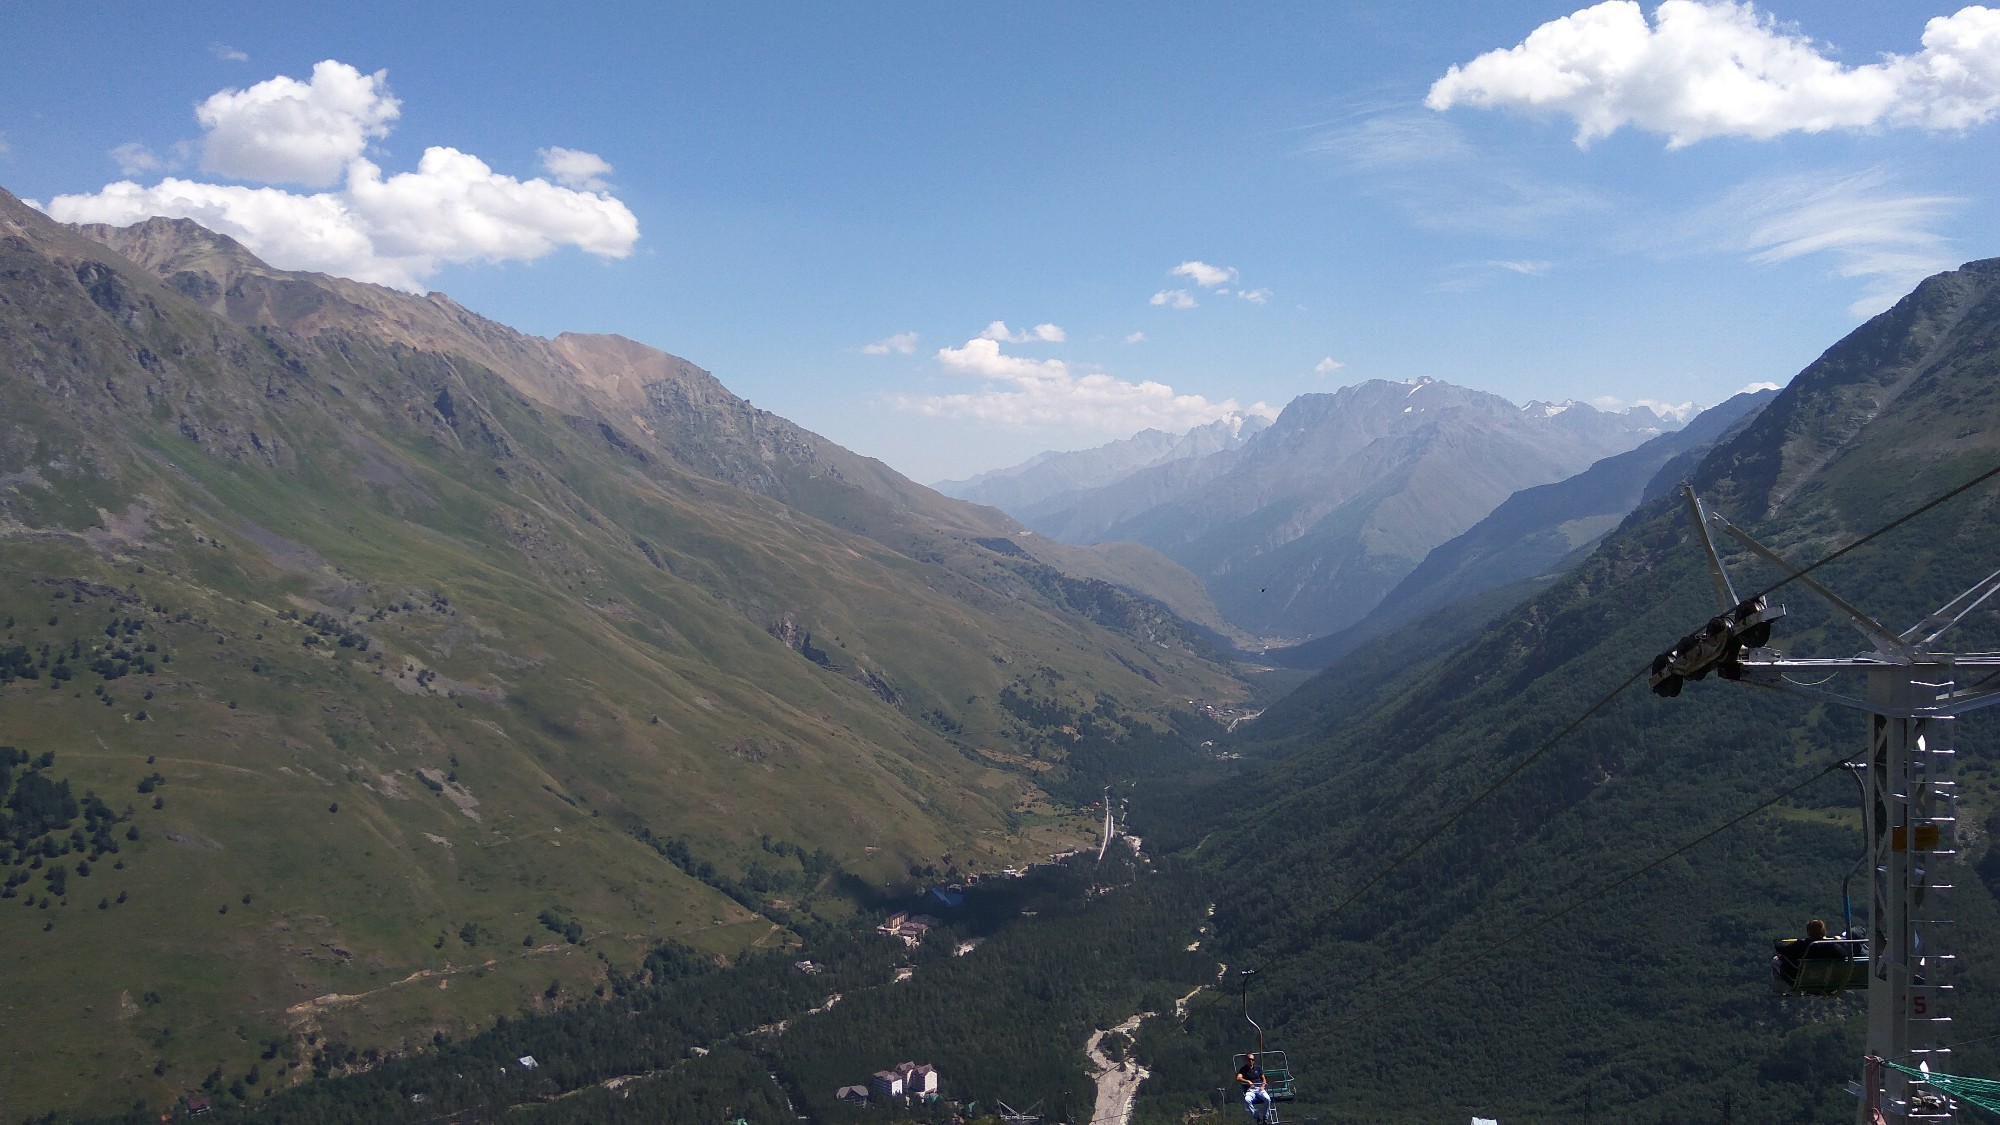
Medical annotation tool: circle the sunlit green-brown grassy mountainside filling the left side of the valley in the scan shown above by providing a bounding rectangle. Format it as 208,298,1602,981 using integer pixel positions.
0,194,1236,1117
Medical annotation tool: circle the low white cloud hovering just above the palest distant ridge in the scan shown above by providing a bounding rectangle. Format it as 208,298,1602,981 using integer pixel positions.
892,336,1276,432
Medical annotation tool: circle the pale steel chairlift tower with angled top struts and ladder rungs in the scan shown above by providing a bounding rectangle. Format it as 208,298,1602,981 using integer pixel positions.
1652,488,2000,1125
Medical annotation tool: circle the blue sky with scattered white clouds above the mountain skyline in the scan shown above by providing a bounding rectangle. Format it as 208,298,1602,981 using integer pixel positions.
0,0,2000,482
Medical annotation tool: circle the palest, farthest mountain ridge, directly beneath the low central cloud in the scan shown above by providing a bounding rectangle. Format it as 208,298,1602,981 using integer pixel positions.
934,412,1270,512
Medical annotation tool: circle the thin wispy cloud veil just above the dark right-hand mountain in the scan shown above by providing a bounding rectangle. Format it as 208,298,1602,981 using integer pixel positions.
1672,168,1964,316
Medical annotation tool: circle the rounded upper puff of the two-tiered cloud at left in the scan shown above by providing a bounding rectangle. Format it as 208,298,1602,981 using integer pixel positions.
194,58,402,188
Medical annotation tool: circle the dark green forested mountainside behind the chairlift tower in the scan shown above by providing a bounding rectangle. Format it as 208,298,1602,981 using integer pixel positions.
1152,260,2000,1123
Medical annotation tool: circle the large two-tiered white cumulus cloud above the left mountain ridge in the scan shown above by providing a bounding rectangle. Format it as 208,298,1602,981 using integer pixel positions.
46,60,638,290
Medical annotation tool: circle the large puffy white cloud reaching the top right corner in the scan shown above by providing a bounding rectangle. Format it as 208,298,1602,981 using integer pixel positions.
1424,0,2000,148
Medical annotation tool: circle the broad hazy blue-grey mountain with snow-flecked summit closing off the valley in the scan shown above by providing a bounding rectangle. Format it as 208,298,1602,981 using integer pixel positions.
1012,378,1674,637
